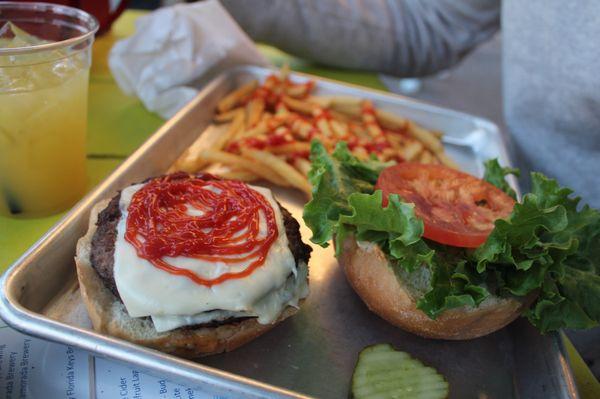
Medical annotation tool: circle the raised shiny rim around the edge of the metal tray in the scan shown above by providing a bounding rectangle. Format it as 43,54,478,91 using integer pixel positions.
0,65,579,399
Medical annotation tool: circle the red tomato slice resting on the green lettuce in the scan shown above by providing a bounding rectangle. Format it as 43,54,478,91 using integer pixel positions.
375,163,515,248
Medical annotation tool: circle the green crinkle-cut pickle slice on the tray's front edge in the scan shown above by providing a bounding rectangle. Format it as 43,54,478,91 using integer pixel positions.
351,344,448,399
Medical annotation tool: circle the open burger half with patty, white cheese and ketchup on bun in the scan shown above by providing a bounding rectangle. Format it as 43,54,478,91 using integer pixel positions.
75,173,311,358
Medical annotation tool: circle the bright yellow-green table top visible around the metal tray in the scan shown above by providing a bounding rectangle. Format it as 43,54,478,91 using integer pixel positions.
0,11,600,399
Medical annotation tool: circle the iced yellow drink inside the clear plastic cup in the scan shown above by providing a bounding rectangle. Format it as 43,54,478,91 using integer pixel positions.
0,69,88,215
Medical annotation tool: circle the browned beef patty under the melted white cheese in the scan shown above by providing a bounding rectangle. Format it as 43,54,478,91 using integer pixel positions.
91,173,312,308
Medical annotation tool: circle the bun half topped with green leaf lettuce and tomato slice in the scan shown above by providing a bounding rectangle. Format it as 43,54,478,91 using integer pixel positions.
304,142,600,340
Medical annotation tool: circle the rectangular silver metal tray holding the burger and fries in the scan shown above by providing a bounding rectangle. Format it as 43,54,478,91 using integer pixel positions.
0,67,578,399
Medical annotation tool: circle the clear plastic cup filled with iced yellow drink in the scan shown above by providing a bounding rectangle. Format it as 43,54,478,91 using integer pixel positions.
0,2,98,217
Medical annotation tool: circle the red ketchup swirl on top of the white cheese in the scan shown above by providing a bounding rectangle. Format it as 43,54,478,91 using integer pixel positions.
125,174,279,287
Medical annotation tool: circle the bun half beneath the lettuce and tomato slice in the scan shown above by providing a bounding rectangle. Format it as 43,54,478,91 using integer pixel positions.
340,237,529,340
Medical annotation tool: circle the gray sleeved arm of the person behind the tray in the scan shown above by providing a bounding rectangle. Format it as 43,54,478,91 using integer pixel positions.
221,0,501,76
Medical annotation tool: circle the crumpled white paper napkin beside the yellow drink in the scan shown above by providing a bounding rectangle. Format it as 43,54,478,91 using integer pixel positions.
108,0,269,118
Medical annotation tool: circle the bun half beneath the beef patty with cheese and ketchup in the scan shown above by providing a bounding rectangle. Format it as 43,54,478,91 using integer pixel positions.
75,201,297,358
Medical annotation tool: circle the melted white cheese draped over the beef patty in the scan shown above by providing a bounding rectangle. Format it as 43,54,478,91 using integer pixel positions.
114,184,308,331
